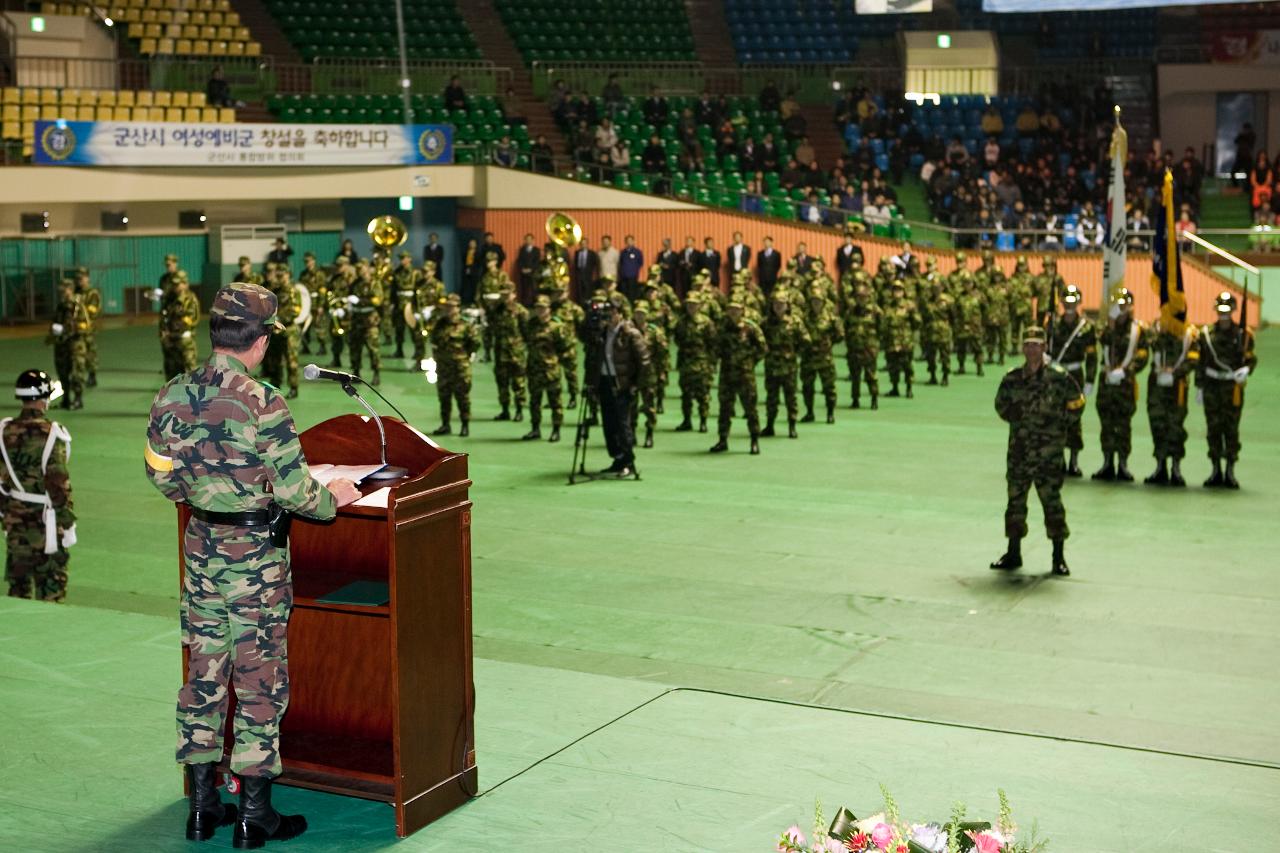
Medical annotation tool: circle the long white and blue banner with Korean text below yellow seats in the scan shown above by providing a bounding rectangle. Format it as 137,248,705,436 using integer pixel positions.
35,120,453,167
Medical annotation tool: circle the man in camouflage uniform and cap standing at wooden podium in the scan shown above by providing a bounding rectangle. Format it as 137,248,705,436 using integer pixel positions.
143,283,360,848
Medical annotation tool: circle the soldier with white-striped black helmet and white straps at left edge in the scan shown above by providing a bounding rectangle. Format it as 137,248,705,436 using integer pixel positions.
0,370,76,601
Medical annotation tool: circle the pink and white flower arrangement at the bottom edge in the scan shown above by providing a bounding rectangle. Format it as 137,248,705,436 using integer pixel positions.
774,785,1048,853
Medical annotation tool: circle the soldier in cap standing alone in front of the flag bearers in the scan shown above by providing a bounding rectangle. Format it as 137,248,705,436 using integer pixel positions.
991,327,1084,575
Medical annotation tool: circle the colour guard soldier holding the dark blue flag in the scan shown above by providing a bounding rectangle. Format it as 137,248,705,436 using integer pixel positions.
1143,320,1199,487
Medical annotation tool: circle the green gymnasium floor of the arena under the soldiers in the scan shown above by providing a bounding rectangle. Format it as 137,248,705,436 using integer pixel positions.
0,325,1280,853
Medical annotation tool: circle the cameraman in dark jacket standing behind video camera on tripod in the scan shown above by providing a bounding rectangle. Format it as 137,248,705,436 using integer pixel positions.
590,298,650,476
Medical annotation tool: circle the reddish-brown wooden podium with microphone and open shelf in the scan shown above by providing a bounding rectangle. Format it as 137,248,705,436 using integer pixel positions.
179,415,477,838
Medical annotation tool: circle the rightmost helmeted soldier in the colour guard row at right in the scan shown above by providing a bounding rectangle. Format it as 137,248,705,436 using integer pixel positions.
1196,291,1258,489
